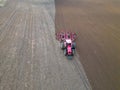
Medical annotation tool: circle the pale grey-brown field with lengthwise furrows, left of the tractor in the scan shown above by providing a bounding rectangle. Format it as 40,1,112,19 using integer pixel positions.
0,0,91,90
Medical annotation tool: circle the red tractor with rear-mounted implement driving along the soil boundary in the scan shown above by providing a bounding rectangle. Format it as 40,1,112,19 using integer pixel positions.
56,32,76,58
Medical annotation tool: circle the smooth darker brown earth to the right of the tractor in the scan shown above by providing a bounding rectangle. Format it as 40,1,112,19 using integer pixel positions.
55,0,120,90
